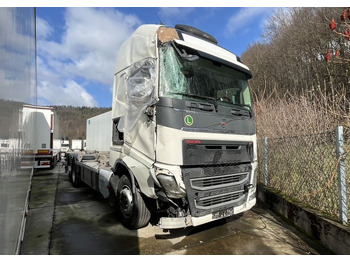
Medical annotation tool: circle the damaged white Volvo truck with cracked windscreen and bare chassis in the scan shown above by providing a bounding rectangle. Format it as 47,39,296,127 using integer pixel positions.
67,25,257,229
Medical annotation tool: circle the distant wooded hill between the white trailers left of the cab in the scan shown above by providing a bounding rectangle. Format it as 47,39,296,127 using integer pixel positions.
54,106,112,140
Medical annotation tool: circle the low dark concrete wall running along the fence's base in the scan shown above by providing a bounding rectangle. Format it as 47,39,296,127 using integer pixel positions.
257,185,350,255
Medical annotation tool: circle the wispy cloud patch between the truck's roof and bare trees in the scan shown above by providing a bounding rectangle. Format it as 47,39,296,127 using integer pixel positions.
226,7,274,36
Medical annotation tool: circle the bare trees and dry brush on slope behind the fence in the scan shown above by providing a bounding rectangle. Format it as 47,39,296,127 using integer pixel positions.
242,7,350,137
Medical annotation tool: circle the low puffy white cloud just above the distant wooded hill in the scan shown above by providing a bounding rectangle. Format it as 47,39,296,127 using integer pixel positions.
38,80,98,107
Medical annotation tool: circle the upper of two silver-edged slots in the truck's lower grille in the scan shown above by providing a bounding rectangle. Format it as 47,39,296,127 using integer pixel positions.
191,173,249,190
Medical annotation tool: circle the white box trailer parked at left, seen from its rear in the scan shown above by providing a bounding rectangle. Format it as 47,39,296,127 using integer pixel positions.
22,105,59,168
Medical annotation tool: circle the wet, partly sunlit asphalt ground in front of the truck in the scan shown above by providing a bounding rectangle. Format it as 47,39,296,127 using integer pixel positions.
21,164,329,255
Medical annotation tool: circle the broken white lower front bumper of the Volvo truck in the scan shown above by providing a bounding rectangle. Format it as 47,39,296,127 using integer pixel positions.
158,198,256,229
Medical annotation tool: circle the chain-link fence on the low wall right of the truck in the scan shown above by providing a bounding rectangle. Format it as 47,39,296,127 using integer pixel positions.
258,129,350,221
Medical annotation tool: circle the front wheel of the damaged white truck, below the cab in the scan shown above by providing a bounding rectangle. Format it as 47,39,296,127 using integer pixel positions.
118,175,151,229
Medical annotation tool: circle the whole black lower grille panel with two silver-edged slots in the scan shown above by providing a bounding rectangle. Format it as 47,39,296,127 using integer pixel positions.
182,164,252,217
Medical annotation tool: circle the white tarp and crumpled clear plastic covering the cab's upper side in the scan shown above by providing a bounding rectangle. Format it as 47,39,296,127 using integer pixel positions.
113,25,161,132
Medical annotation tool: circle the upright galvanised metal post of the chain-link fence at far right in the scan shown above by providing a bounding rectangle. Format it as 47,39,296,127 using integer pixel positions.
336,126,348,224
